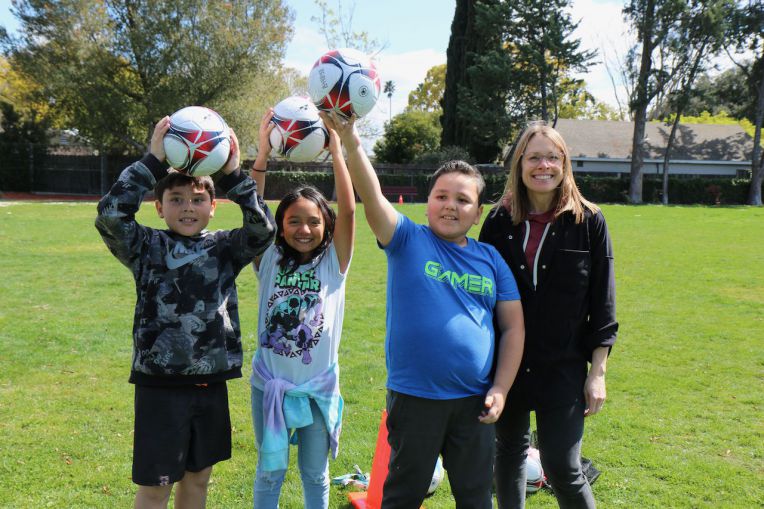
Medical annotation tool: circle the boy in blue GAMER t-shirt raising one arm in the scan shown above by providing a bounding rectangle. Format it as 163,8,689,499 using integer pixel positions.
322,114,525,509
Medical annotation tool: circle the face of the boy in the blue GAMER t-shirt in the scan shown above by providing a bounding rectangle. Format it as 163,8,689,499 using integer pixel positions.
427,172,483,246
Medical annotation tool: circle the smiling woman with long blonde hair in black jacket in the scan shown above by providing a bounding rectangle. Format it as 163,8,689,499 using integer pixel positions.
480,123,618,509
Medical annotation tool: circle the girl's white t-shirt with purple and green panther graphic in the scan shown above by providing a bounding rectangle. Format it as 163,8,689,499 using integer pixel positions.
251,244,347,390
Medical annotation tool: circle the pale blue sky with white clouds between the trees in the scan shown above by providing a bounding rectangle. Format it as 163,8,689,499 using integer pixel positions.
0,0,631,124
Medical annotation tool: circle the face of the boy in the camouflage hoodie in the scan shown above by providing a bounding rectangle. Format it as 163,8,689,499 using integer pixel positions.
155,184,216,237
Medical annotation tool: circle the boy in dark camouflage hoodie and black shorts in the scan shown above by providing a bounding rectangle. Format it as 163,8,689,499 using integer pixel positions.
96,117,275,508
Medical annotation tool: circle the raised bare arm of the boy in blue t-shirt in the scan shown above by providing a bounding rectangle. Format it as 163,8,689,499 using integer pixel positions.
320,112,398,246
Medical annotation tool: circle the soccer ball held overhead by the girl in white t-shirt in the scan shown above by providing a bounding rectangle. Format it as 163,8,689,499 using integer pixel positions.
270,95,329,163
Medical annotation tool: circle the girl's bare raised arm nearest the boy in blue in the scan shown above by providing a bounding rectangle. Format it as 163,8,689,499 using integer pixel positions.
327,121,355,274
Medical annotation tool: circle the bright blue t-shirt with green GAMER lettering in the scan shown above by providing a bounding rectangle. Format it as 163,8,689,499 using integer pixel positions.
384,214,520,399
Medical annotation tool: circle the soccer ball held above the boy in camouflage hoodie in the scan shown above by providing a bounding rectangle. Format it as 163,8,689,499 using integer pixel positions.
163,106,231,176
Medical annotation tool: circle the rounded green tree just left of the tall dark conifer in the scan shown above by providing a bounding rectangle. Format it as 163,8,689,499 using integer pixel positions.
374,111,440,163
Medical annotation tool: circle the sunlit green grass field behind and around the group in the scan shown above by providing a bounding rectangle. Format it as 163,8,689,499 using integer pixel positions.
0,202,764,509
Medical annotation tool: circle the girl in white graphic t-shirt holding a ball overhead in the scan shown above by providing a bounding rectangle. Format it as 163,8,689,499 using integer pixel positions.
250,110,355,509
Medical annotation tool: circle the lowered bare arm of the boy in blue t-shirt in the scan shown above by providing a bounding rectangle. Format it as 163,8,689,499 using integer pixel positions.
478,300,525,424
